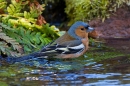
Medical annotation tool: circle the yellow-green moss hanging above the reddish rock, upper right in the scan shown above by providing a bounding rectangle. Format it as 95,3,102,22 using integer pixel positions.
65,0,126,25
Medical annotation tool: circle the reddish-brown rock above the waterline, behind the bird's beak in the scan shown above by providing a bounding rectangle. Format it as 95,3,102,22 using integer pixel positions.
89,6,130,38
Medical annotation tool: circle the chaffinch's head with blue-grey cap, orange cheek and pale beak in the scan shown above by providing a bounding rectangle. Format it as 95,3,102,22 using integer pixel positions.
68,21,94,40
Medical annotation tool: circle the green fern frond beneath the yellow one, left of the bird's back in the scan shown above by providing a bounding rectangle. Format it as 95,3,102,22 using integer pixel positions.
0,23,51,53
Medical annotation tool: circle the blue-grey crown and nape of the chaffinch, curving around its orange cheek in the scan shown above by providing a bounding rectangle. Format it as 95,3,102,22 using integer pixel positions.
68,21,89,39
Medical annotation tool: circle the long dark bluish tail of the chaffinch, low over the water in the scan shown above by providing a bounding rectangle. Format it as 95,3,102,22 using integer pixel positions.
6,52,45,63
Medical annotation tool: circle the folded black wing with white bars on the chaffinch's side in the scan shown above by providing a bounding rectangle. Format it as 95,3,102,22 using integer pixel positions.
39,40,85,56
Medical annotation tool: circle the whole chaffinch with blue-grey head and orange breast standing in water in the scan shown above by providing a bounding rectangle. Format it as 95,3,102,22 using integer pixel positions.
6,21,94,62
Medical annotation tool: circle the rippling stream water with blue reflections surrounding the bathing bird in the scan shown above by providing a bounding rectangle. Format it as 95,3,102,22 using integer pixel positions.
0,39,130,86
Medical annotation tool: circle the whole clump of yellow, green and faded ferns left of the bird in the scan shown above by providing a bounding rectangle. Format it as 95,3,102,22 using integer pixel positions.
0,0,60,56
